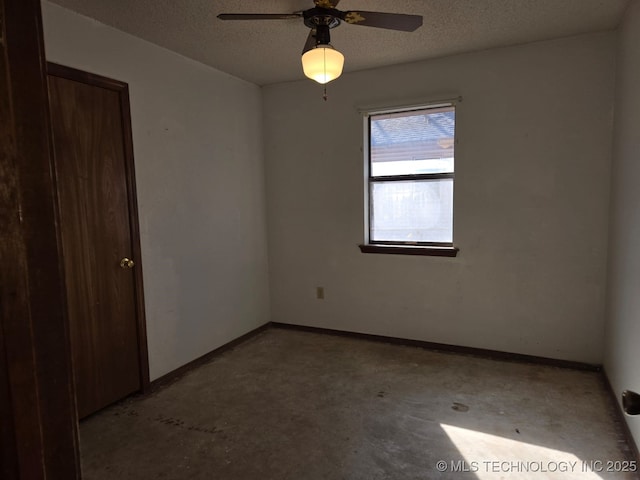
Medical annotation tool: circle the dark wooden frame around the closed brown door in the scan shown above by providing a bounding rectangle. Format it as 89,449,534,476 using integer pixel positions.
47,62,150,393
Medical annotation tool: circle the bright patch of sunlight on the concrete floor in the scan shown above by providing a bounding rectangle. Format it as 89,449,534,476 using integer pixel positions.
436,424,602,480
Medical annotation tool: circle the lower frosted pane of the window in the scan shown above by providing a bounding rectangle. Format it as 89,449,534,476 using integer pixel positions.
370,178,453,243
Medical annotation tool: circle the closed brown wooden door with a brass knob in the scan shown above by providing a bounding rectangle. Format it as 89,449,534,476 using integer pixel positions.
49,64,148,418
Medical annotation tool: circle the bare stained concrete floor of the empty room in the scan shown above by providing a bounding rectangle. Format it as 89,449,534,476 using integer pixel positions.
81,328,638,480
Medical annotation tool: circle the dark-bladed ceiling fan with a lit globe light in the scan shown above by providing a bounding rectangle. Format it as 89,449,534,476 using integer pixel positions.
218,0,422,83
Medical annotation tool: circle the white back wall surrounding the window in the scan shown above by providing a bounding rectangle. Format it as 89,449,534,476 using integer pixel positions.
263,33,615,363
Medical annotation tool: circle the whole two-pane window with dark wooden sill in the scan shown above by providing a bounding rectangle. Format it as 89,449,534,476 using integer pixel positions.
360,104,457,256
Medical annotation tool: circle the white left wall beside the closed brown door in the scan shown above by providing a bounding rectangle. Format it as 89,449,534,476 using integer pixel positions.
43,2,269,379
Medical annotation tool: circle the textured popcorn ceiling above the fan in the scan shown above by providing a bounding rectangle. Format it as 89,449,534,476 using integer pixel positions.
47,0,629,85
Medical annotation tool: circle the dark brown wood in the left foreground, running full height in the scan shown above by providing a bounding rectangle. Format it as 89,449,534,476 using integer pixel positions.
0,0,80,480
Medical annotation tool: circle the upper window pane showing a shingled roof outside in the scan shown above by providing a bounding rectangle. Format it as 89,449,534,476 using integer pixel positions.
370,107,455,177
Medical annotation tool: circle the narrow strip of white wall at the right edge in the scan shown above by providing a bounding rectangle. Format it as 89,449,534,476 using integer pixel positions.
605,1,640,450
